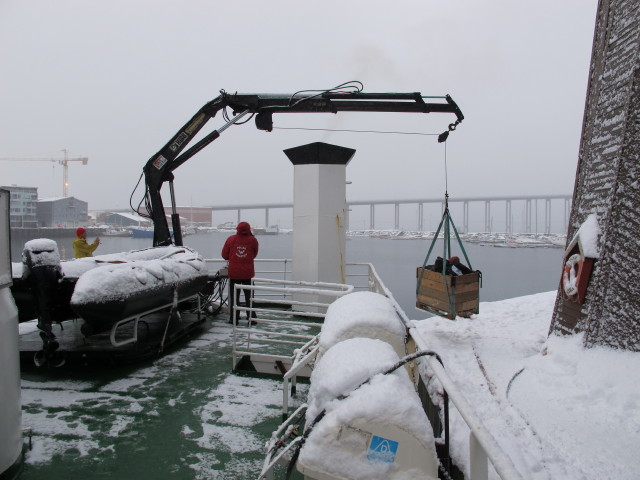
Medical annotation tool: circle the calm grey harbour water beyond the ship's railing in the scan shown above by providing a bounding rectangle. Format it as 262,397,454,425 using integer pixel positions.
11,231,563,318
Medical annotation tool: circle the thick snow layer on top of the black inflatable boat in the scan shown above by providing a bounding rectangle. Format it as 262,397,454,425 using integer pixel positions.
71,247,207,305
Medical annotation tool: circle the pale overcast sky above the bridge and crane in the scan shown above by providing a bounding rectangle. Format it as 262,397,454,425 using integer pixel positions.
0,0,597,210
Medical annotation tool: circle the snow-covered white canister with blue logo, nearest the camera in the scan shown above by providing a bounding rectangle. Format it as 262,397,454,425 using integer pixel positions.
297,338,438,480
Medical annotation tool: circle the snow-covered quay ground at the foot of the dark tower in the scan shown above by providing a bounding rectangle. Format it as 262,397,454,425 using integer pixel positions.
414,291,640,480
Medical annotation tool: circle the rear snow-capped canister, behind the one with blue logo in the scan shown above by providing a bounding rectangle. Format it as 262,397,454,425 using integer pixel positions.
318,292,406,356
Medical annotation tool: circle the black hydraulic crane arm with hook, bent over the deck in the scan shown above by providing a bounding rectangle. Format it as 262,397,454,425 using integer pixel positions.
143,90,464,246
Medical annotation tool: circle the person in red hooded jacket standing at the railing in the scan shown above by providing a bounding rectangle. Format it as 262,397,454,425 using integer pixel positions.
222,222,258,325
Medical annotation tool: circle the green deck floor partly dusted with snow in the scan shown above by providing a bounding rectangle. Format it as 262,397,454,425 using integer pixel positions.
21,314,307,480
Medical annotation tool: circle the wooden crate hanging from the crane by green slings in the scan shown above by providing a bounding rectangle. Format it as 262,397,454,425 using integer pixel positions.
416,267,481,320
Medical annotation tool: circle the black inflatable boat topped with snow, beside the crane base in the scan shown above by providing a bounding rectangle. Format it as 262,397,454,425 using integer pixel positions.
11,239,208,335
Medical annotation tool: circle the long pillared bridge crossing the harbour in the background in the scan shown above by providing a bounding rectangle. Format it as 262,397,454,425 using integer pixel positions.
213,195,572,233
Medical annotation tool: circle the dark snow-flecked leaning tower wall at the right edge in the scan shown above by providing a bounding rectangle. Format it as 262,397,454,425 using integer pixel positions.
550,0,640,351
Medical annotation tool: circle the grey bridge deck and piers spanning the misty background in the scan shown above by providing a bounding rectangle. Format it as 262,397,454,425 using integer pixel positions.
212,195,572,233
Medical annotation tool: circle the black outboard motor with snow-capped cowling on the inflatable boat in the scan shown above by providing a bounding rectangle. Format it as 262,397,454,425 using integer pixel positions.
22,238,64,367
